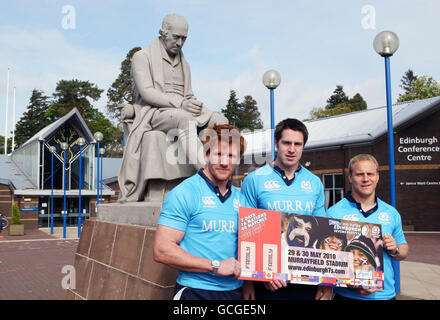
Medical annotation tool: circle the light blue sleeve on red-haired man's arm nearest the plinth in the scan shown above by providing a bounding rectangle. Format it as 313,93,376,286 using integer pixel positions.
157,188,196,231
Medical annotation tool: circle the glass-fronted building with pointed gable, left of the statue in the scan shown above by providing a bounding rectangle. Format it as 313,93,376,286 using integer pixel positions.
10,109,104,227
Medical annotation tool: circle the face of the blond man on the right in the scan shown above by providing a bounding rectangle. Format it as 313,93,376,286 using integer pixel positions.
348,160,379,198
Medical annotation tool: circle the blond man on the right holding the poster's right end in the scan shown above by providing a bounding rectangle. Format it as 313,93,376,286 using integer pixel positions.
327,154,408,300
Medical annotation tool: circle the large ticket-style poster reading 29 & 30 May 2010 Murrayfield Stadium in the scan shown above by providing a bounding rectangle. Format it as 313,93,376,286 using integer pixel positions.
238,207,384,289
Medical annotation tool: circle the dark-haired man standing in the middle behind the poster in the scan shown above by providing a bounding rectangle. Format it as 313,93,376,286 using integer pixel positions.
241,119,332,300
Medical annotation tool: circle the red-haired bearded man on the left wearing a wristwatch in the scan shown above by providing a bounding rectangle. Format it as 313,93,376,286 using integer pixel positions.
154,124,245,300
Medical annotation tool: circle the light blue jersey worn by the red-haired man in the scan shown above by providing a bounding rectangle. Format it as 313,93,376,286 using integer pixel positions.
158,170,243,291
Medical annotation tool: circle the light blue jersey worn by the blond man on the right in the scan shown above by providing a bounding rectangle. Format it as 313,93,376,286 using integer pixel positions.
327,193,406,300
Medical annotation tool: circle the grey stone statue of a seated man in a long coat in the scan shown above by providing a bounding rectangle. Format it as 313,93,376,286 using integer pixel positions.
118,14,228,202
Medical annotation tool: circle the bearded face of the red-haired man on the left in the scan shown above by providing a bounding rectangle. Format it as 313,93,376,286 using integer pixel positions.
205,141,240,184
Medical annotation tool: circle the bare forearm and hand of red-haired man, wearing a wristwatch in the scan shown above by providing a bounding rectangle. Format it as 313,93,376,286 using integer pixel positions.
153,225,241,278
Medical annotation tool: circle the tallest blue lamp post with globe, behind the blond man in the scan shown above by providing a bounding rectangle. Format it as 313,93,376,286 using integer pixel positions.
373,31,400,292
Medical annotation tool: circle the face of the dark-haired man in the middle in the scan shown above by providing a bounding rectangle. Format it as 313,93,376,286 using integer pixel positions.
275,129,304,169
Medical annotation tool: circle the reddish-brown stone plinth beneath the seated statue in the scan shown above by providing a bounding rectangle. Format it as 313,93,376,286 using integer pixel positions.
67,202,177,300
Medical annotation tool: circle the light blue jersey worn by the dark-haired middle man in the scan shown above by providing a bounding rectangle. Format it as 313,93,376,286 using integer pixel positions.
241,164,325,217
